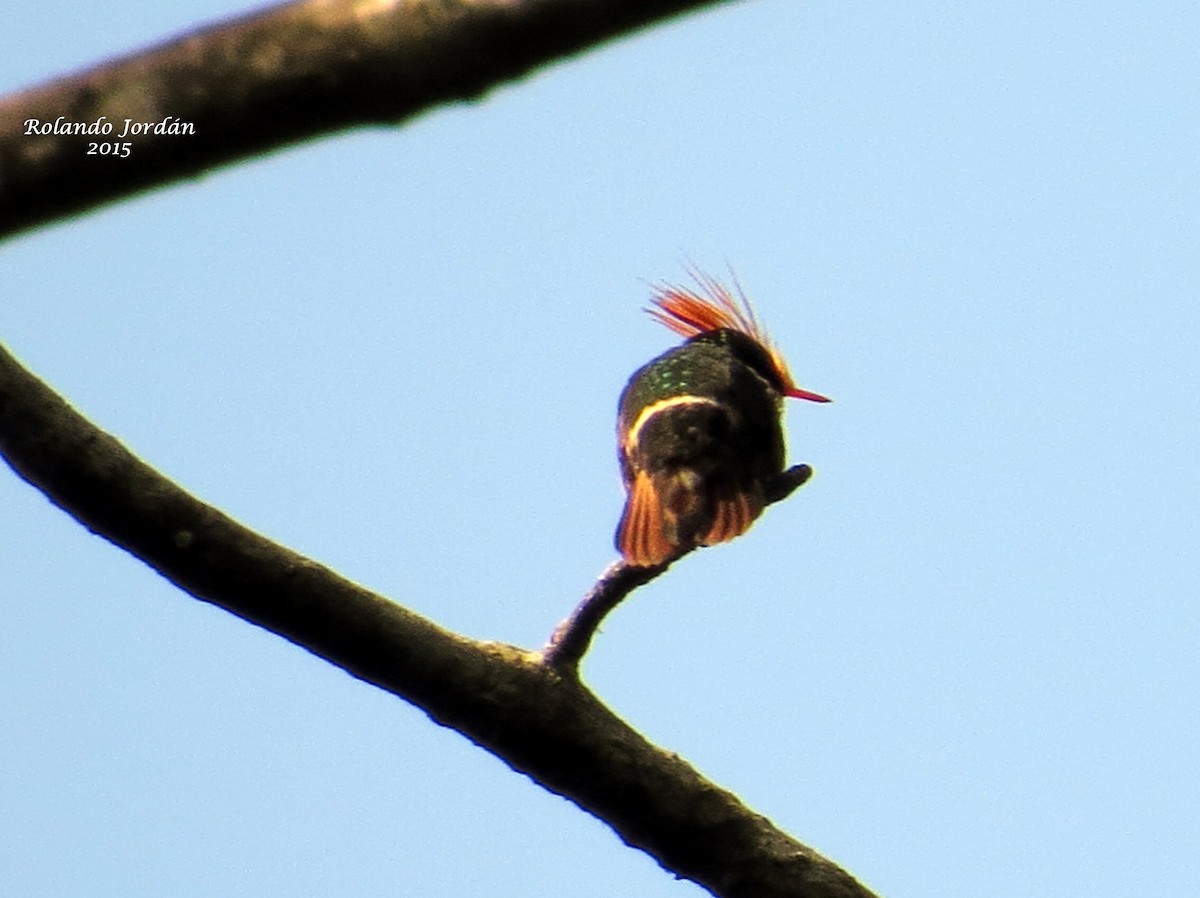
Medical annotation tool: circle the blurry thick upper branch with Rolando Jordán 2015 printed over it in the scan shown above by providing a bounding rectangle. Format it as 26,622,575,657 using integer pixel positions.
0,0,722,238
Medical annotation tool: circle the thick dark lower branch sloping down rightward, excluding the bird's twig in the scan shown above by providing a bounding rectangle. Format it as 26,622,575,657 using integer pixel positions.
0,340,871,898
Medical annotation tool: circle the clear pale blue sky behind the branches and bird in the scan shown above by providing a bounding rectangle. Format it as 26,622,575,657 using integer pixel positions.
0,0,1200,898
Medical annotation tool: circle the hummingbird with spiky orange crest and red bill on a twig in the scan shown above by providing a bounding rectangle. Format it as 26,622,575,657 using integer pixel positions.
616,271,830,568
